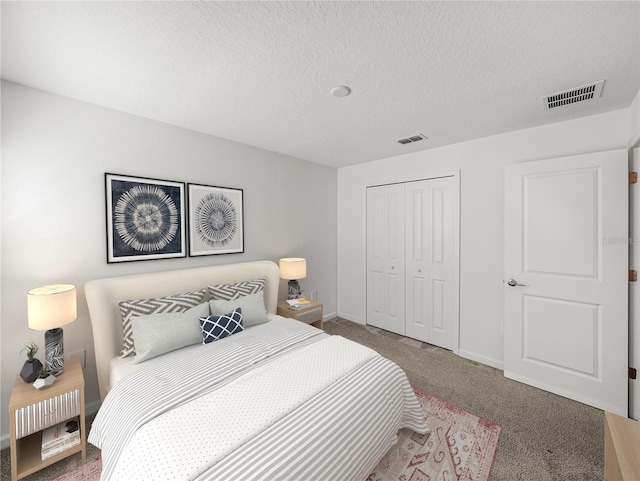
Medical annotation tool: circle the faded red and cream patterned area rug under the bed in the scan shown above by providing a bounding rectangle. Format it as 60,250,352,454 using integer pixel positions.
54,388,501,481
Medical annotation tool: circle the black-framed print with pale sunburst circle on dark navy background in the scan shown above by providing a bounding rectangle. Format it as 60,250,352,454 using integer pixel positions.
105,173,187,263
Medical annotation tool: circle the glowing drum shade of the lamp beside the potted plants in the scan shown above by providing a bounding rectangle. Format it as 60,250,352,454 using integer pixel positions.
27,284,78,331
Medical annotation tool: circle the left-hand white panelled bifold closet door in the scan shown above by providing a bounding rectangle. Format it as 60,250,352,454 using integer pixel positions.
367,184,405,335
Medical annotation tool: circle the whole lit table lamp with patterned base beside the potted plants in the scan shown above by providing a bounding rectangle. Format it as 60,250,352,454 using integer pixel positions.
27,284,78,376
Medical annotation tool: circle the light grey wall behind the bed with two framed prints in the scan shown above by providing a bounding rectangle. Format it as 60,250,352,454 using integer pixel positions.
0,82,337,447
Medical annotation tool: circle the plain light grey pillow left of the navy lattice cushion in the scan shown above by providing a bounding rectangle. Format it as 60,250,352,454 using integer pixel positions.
131,302,209,364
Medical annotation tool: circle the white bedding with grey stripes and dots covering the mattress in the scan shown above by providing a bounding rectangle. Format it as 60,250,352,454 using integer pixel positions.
89,316,428,480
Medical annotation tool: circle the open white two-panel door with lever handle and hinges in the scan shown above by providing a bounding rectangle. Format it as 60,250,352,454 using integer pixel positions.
504,150,629,416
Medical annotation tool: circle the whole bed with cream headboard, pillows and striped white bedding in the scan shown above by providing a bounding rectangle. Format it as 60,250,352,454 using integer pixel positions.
85,261,428,481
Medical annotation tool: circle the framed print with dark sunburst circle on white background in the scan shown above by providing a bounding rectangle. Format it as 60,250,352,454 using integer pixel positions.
187,184,244,256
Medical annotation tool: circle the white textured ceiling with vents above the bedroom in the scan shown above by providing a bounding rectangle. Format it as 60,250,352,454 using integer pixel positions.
0,1,640,167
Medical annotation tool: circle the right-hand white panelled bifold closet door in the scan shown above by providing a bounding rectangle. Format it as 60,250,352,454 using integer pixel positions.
405,177,456,349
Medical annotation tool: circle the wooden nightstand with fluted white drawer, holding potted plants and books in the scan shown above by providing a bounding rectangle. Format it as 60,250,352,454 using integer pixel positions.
9,358,87,481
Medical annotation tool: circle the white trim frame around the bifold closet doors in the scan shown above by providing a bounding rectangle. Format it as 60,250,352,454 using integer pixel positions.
362,169,460,355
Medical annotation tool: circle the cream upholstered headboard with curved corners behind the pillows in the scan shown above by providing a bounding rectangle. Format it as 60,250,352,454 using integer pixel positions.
85,261,280,399
